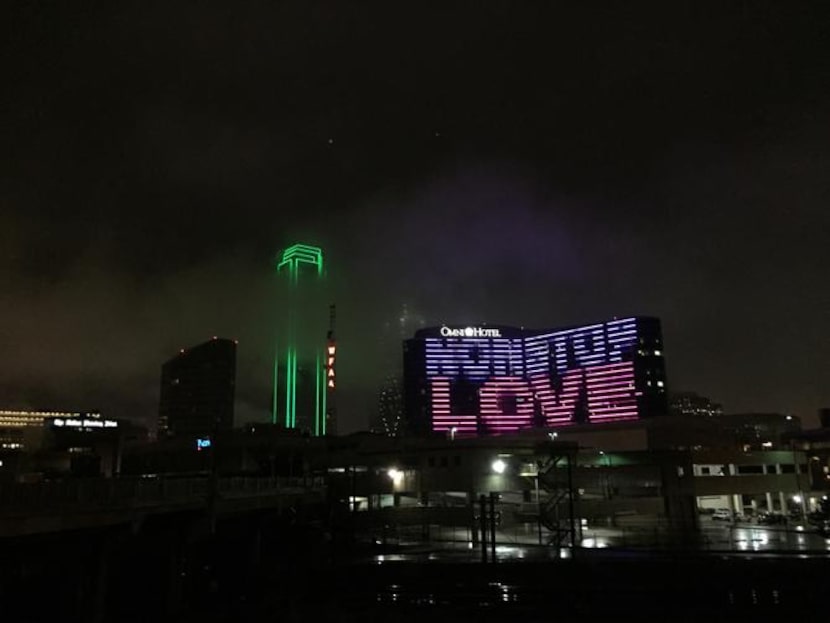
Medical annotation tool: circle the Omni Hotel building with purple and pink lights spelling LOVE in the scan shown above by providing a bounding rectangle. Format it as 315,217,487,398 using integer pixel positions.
404,317,667,436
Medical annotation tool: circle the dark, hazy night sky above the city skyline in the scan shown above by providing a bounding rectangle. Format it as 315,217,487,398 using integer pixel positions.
0,0,830,431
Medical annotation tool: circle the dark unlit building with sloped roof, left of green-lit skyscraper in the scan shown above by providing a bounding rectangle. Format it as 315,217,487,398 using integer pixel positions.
158,338,236,437
